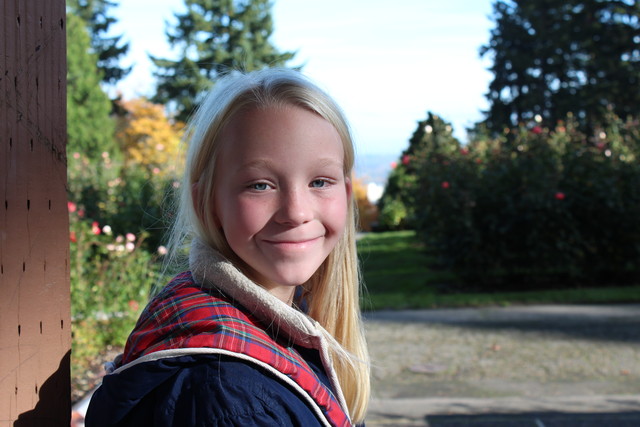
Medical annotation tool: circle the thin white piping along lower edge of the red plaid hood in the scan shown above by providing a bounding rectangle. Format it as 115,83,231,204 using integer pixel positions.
109,347,332,427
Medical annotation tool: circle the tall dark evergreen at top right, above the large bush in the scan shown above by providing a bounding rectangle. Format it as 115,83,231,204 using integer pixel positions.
480,0,640,131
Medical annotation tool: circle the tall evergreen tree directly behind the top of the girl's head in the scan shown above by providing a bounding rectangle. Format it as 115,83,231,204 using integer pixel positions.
151,0,294,121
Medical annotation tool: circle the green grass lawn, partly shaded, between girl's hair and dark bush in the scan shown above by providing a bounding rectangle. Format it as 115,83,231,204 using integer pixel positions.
358,231,640,310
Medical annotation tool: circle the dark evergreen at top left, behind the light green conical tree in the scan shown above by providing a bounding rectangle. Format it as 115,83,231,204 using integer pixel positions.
67,0,131,84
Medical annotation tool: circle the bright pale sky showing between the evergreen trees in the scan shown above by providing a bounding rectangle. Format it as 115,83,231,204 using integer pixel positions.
110,0,493,156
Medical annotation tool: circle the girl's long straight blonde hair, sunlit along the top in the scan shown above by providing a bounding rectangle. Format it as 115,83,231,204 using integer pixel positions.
169,69,370,423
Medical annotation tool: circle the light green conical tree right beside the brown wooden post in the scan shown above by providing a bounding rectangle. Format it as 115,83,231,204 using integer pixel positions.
67,14,117,160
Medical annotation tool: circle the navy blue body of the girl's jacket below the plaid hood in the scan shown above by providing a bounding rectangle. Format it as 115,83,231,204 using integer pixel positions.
85,350,338,427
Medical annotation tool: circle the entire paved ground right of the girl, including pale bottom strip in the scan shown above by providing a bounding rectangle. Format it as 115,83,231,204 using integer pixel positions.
365,305,640,427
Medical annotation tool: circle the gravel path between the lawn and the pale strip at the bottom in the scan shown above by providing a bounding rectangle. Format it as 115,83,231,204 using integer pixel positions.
365,305,640,425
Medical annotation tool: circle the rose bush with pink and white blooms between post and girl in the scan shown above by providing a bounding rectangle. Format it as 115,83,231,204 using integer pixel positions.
67,153,174,388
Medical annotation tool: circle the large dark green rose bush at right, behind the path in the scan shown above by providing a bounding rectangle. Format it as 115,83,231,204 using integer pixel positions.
415,113,640,289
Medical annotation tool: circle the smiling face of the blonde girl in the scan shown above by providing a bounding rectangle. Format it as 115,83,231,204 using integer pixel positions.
214,106,351,302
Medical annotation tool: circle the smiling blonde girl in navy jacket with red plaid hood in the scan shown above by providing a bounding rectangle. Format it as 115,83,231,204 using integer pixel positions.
86,69,369,427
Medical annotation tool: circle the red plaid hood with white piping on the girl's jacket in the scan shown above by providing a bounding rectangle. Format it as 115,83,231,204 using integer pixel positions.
116,272,351,426
